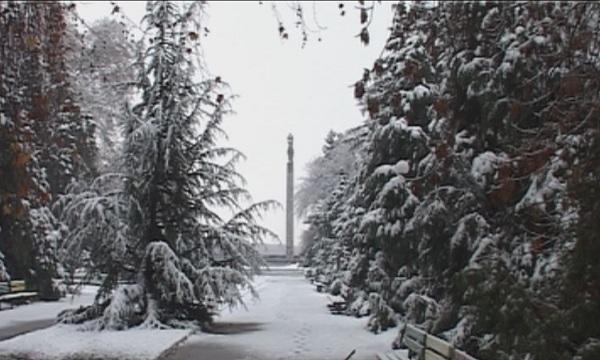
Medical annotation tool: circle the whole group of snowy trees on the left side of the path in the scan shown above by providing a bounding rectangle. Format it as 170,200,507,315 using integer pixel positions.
0,1,276,329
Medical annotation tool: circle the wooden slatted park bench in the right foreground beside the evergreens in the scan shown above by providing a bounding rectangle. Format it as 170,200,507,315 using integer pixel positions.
376,324,477,360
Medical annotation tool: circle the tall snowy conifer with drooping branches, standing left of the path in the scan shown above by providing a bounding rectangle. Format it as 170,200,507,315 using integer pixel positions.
61,1,275,329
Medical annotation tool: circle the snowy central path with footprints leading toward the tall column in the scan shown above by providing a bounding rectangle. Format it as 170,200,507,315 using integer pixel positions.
165,272,397,360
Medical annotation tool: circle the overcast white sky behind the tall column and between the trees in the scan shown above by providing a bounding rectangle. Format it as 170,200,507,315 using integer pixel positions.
77,1,391,245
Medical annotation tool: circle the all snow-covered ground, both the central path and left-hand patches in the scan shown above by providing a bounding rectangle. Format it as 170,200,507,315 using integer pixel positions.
0,268,404,360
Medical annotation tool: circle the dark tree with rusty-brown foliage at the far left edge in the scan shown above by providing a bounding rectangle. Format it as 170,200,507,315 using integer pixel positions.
0,1,95,297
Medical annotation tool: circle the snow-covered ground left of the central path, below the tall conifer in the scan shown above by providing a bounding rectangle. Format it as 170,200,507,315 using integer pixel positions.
0,286,190,360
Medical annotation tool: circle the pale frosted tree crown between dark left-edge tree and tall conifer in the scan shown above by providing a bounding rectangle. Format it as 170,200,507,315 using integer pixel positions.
69,18,139,173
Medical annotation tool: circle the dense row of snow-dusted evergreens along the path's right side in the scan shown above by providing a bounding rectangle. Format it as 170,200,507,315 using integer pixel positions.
306,2,600,359
